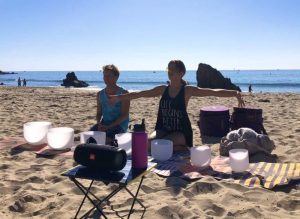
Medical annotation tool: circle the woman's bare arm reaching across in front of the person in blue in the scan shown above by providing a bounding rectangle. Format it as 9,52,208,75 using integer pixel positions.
108,85,166,103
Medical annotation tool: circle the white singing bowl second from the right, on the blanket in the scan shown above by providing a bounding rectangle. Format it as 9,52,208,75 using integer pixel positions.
190,146,211,167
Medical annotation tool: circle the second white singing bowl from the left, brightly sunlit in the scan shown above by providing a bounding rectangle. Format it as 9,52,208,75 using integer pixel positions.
47,127,74,150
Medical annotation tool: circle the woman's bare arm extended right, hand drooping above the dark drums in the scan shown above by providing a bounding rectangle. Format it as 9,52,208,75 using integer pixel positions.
186,86,245,107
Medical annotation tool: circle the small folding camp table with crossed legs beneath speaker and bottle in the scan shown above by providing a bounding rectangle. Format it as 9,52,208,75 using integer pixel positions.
62,160,156,218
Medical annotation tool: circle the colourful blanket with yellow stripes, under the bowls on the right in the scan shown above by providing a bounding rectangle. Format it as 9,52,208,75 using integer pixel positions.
153,153,300,189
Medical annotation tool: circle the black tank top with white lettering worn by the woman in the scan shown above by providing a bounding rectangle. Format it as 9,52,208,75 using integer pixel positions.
155,85,193,147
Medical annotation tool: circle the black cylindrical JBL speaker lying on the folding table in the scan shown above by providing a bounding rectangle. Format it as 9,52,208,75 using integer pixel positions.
74,144,127,171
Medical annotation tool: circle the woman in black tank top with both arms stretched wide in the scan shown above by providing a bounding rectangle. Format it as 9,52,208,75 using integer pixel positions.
109,60,245,151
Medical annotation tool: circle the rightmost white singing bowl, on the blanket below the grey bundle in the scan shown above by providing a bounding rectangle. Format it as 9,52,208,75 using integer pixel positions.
229,149,249,172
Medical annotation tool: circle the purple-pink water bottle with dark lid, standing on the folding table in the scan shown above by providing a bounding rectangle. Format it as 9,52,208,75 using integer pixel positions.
132,119,148,169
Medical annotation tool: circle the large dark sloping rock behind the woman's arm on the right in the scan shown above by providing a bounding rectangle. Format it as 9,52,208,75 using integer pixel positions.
197,63,241,91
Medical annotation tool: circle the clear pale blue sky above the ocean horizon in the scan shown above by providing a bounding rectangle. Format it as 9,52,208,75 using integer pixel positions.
0,0,300,71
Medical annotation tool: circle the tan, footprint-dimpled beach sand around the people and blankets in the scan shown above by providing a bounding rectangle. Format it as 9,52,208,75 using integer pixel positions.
0,87,300,219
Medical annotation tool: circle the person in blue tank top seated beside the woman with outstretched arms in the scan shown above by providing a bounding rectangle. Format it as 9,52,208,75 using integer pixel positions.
91,65,130,144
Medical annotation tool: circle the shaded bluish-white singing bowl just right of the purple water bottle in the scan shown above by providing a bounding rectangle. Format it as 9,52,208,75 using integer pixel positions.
151,139,173,161
